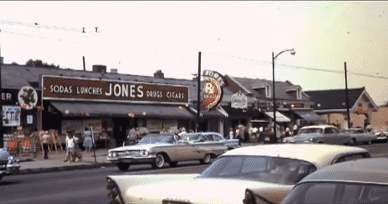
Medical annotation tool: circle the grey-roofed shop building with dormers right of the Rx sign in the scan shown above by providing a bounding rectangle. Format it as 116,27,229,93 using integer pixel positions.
221,75,322,138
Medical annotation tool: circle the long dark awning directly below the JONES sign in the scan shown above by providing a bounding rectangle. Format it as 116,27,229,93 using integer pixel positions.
51,101,195,119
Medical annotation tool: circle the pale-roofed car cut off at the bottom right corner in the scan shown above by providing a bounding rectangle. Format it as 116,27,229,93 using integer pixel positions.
282,158,388,204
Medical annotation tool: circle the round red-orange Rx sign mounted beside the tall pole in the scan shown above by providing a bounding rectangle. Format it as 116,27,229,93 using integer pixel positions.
202,77,222,109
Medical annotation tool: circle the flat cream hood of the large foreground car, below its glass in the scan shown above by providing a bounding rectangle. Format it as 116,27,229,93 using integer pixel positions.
110,174,292,204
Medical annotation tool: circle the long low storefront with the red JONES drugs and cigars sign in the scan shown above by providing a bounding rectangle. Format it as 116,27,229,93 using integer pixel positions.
1,64,227,145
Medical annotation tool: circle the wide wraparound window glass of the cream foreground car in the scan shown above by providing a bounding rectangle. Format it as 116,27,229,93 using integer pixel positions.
201,156,317,185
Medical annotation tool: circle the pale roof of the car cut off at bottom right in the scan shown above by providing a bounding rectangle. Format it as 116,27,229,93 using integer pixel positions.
299,158,388,185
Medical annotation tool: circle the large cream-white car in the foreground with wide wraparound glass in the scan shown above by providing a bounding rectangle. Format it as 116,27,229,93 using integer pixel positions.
107,144,370,204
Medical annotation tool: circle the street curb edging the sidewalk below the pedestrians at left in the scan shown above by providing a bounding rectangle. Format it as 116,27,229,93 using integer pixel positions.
11,162,115,176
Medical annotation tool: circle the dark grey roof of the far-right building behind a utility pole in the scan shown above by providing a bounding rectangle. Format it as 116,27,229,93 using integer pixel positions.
305,87,365,110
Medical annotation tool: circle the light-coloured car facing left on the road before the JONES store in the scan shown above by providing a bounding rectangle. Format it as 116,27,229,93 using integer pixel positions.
107,132,239,171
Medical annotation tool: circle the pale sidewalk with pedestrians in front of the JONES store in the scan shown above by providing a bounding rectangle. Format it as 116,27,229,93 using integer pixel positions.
10,143,258,175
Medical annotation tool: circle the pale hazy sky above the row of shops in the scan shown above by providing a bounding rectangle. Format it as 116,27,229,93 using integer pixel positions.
0,1,388,105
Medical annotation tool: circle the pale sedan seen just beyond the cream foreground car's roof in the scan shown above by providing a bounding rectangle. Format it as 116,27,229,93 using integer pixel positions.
283,125,355,145
